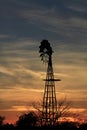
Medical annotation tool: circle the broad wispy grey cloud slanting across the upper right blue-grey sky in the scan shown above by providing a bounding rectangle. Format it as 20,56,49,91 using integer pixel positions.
18,4,87,44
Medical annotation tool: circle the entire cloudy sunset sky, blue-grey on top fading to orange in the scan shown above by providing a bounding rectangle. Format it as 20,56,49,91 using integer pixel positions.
0,0,87,123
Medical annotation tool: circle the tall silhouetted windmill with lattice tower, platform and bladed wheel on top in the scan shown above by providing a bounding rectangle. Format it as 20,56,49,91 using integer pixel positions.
39,40,60,125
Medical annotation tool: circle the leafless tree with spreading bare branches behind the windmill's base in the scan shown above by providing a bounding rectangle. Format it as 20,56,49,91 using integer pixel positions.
32,97,78,124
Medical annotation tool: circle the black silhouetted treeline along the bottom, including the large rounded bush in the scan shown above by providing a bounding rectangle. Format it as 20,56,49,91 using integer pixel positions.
0,112,87,130
